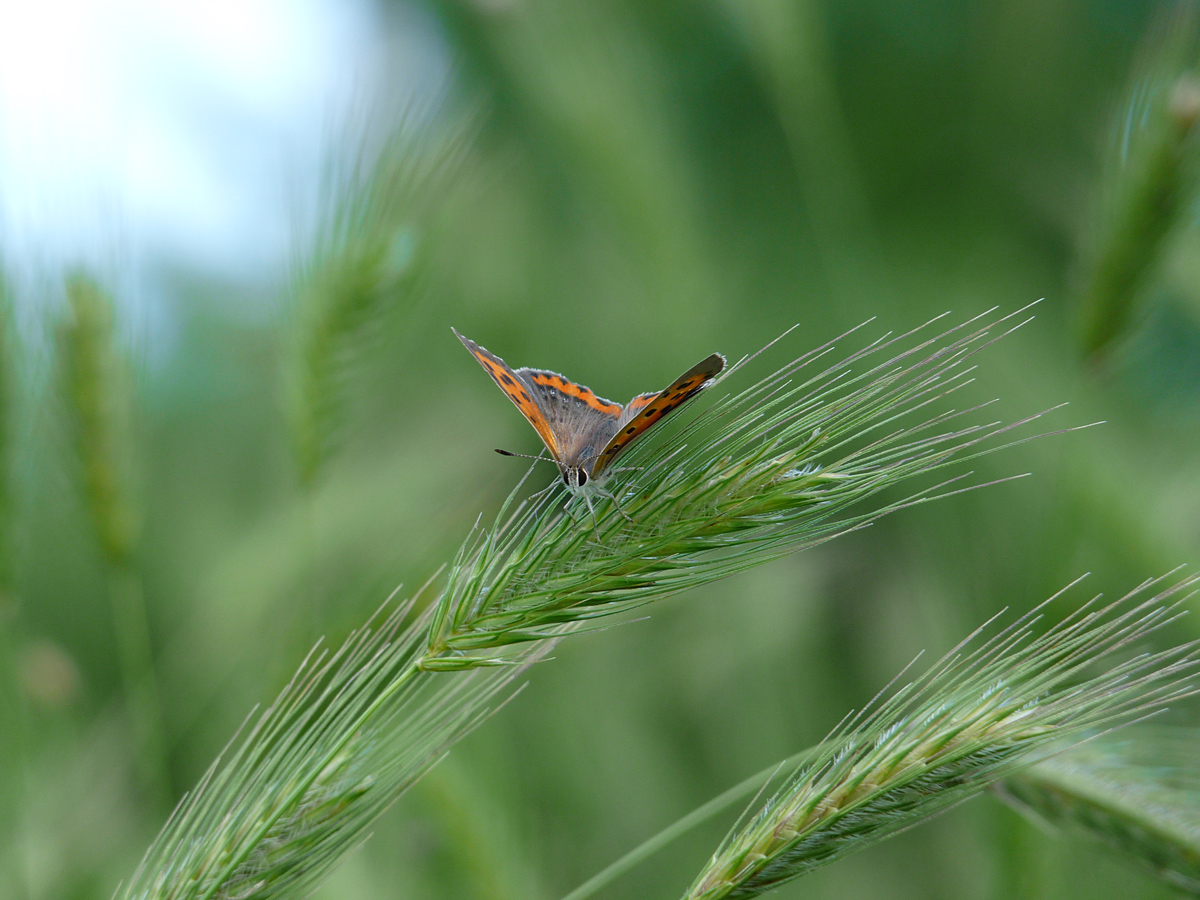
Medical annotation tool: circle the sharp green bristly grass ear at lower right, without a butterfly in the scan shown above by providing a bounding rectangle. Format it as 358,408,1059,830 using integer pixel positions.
684,577,1200,900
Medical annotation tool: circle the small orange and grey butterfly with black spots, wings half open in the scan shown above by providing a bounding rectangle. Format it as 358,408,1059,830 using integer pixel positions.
451,329,725,496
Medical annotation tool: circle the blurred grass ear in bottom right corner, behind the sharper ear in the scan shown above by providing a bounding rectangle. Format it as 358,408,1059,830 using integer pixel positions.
995,726,1200,896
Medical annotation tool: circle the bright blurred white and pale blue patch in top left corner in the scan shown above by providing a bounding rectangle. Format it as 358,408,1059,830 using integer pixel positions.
0,0,446,303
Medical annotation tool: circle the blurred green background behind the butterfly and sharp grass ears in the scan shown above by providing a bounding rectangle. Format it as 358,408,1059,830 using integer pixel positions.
7,0,1200,900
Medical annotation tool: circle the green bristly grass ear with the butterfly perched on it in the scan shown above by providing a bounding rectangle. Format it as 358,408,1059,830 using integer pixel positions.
422,313,1070,671
